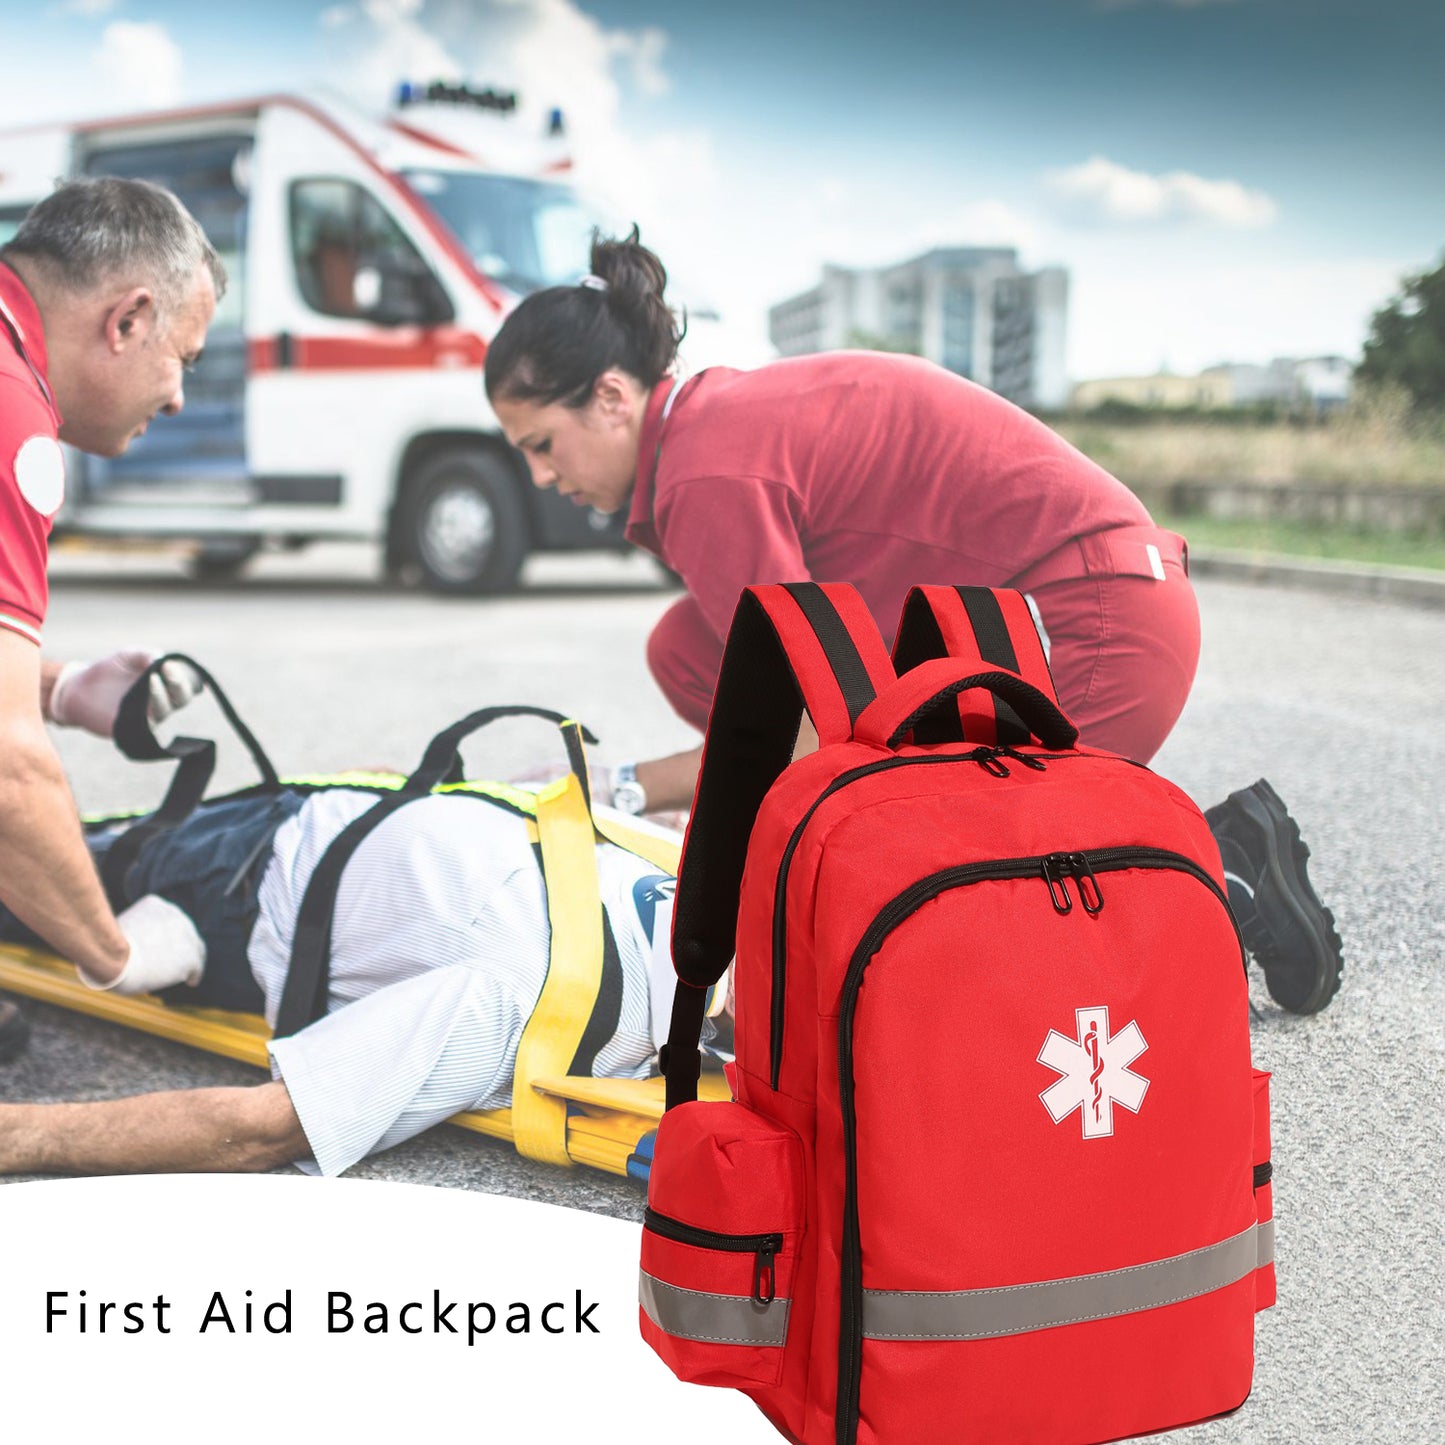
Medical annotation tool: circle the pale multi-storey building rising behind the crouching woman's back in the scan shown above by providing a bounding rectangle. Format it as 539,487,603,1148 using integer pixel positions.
767,246,1069,409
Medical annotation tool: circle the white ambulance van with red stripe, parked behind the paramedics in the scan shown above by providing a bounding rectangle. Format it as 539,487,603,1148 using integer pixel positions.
0,84,664,592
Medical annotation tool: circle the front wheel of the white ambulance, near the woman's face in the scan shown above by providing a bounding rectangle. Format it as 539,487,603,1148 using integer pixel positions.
397,451,532,592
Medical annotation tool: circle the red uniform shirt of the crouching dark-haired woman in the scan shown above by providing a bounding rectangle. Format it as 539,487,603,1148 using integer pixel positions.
627,353,1149,656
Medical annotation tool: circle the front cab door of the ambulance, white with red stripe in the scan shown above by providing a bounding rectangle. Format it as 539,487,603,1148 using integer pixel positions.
247,107,471,538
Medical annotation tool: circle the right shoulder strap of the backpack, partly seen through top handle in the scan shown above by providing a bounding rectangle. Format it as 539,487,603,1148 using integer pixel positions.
893,587,1058,747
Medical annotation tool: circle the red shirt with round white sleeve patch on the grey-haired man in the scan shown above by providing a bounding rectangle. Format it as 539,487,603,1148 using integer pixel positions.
0,262,65,643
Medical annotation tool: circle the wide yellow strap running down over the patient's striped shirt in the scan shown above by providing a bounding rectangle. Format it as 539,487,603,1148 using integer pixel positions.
512,773,603,1165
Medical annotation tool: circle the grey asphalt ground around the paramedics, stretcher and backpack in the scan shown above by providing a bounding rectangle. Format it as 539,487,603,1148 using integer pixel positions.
0,548,1445,1445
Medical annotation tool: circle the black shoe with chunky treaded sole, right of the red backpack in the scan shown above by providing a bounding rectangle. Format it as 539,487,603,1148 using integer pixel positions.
1204,777,1344,1013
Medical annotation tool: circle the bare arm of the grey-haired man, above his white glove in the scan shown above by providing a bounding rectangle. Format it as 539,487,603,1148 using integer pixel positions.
0,629,130,983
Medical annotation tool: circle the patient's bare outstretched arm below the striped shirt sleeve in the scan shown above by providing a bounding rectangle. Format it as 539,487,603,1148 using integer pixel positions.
0,1082,311,1173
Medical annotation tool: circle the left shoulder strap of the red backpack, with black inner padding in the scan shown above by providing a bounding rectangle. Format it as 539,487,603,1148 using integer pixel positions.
662,582,894,1108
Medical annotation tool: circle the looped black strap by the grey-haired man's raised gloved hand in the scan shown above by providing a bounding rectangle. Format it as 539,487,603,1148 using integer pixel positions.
100,652,280,910
